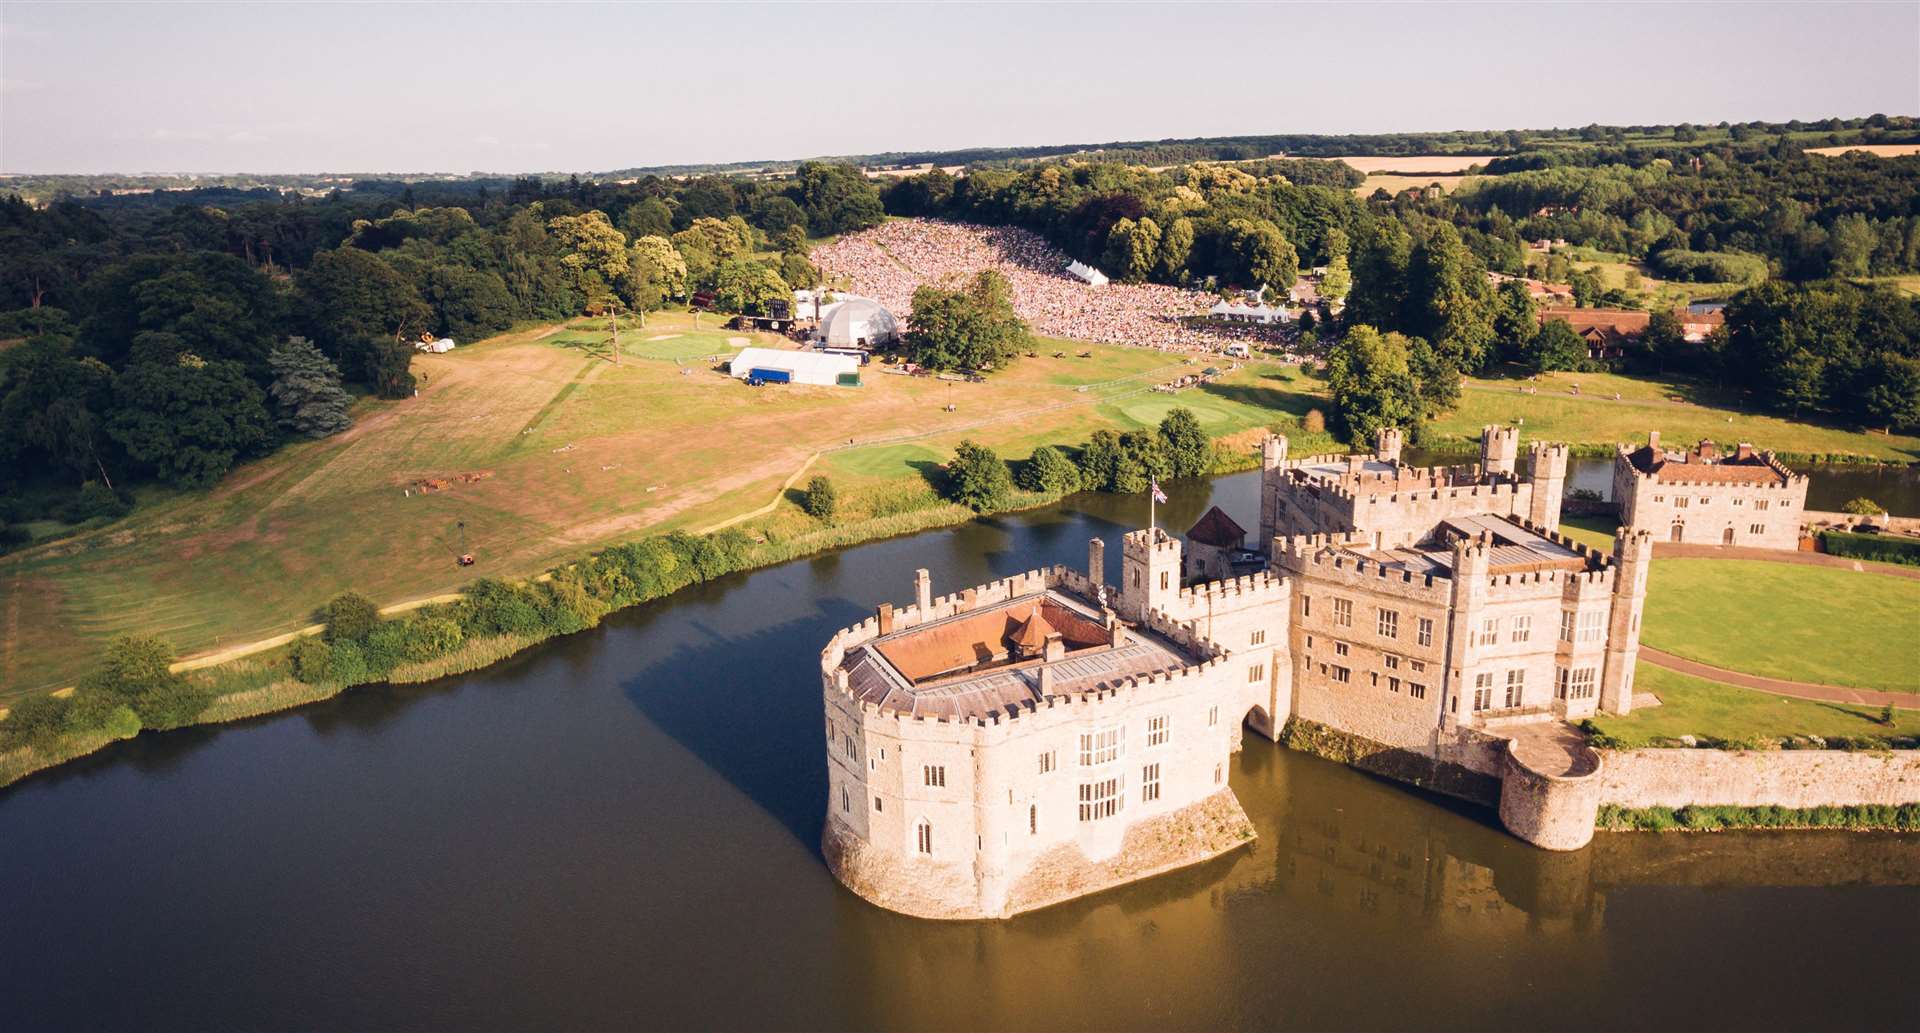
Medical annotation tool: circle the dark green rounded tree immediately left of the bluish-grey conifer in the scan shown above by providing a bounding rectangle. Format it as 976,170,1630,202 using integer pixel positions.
108,353,269,488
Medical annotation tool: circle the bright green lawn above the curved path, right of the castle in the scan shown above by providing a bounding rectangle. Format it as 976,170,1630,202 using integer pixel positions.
1640,559,1920,693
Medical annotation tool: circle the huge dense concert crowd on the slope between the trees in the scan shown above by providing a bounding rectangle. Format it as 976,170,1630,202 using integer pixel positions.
810,219,1288,351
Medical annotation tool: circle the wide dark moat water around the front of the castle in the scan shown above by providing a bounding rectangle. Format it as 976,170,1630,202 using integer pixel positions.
0,474,1920,1029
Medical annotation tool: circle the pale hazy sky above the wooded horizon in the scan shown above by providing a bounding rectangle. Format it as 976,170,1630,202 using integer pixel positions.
0,0,1920,173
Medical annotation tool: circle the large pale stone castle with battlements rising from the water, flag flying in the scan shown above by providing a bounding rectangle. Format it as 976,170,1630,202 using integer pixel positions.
822,426,1651,918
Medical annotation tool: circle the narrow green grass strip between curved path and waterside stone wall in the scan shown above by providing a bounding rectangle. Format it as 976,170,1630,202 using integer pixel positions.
1594,662,1920,747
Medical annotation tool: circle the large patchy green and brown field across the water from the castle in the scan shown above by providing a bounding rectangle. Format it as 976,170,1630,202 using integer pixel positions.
0,315,1284,697
